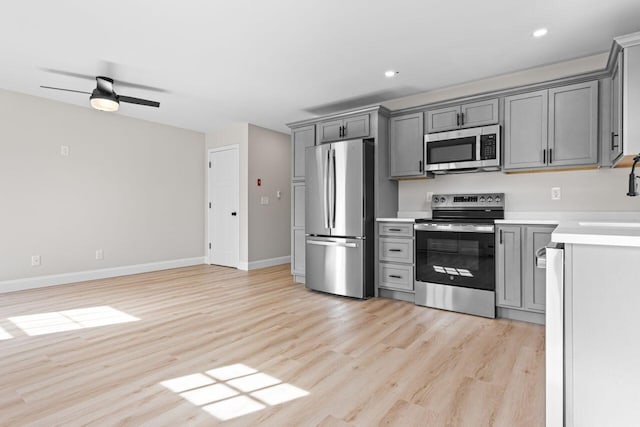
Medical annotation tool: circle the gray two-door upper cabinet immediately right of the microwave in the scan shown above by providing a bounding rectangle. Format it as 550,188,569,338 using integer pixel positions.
504,81,598,170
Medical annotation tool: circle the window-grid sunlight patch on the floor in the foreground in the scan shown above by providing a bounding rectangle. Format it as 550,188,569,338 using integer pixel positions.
160,363,309,421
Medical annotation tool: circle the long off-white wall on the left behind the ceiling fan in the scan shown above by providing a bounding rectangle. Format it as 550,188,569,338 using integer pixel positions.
0,91,204,284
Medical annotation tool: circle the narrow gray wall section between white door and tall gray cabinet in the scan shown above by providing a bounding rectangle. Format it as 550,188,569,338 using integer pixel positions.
248,125,291,262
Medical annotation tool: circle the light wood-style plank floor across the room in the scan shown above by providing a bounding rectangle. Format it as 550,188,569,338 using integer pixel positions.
0,265,544,427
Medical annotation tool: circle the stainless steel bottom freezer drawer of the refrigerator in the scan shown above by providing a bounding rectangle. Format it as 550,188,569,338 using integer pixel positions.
305,236,367,298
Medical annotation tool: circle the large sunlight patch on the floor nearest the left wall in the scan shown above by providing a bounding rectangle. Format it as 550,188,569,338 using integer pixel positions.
8,305,140,336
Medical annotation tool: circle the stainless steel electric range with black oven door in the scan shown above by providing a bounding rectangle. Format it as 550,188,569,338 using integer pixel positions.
414,193,504,318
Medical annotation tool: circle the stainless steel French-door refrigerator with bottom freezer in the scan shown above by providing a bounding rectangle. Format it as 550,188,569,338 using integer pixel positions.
305,139,374,298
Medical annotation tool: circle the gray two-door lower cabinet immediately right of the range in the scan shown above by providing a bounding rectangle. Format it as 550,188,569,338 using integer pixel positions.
496,225,555,320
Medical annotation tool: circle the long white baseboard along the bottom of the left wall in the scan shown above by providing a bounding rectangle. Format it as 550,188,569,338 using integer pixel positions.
0,257,206,293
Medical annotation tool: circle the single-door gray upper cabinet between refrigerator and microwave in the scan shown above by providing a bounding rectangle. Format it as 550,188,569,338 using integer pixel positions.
389,113,424,178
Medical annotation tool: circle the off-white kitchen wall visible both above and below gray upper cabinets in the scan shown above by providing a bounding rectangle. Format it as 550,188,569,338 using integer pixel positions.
384,53,640,212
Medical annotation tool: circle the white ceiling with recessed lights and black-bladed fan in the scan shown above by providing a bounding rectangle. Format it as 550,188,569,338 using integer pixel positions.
0,0,640,132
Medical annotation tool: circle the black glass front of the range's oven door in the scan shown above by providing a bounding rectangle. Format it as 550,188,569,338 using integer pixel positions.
416,231,495,291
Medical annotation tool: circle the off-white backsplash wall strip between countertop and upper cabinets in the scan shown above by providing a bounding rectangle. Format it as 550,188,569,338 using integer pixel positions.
398,168,640,214
